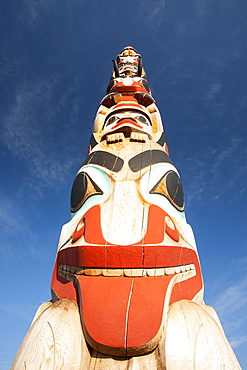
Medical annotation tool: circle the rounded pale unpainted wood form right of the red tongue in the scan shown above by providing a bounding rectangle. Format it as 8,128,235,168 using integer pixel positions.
164,300,241,370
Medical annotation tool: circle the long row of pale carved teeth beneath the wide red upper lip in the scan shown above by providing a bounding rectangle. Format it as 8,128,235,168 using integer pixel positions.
58,263,195,281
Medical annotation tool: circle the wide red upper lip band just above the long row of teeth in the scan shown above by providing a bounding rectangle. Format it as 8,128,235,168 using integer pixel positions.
55,245,198,268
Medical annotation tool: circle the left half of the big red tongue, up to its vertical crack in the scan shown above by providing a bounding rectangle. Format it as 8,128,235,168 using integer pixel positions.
77,276,132,348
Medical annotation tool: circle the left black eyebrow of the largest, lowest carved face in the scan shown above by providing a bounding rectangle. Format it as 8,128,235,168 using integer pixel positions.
82,150,124,172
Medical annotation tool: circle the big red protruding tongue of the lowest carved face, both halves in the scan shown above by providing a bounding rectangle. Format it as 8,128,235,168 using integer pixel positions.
77,276,172,348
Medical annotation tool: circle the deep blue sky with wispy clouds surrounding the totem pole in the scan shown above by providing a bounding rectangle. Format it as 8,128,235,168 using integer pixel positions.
0,0,247,370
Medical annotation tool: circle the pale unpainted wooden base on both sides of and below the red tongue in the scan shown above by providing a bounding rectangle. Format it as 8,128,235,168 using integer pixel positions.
11,299,241,370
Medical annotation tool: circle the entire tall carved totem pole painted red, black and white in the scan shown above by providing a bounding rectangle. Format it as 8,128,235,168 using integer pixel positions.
12,46,240,370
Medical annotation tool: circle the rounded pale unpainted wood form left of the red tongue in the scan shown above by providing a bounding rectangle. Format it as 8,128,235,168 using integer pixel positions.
11,299,90,370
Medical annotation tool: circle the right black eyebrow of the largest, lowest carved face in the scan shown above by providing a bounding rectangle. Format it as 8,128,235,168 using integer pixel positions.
129,149,173,172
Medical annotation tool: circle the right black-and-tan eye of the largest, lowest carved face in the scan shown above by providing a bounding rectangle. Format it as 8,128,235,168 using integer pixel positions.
150,171,184,211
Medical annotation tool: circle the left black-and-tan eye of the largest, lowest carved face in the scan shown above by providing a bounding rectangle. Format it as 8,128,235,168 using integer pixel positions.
70,172,103,212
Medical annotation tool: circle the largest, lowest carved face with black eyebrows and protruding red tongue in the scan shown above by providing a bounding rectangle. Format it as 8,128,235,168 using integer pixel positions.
52,138,203,355
